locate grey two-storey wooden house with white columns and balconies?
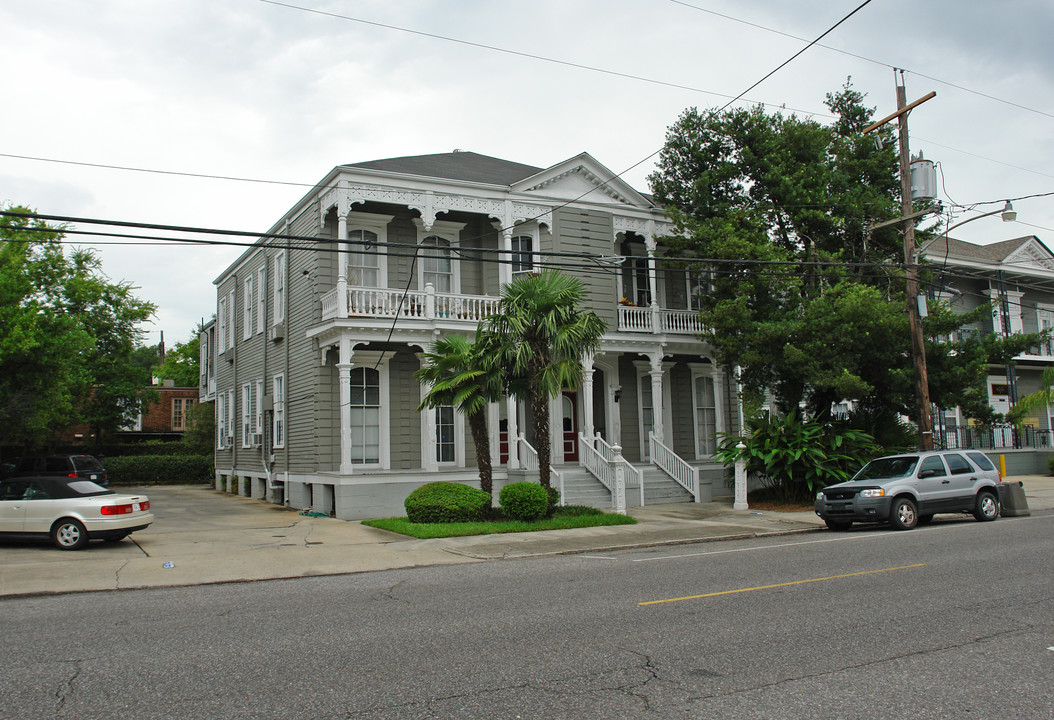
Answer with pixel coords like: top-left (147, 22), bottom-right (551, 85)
top-left (205, 152), bottom-right (740, 519)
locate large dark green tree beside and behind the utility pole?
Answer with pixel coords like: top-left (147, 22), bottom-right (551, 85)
top-left (648, 82), bottom-right (1036, 425)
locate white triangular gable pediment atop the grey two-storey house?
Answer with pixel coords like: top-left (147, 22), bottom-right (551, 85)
top-left (512, 153), bottom-right (651, 208)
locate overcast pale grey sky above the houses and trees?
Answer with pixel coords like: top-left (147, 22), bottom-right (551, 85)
top-left (0, 0), bottom-right (1054, 347)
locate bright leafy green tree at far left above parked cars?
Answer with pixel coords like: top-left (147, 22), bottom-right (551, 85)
top-left (0, 207), bottom-right (154, 447)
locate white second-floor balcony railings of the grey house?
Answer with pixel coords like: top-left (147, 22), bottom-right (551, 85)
top-left (321, 285), bottom-right (703, 335)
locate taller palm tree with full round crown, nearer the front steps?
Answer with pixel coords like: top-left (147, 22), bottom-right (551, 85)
top-left (487, 270), bottom-right (605, 488)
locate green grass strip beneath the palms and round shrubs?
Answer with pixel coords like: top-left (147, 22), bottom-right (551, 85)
top-left (363, 505), bottom-right (637, 540)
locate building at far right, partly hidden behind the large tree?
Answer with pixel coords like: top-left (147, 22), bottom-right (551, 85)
top-left (921, 235), bottom-right (1054, 448)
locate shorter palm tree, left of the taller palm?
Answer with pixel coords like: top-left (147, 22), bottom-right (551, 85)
top-left (414, 335), bottom-right (502, 495)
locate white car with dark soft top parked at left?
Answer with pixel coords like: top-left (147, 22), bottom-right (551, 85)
top-left (0, 478), bottom-right (154, 550)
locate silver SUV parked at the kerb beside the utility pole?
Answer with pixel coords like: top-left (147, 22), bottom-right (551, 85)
top-left (815, 450), bottom-right (1003, 530)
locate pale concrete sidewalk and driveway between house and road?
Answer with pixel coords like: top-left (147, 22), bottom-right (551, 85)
top-left (0, 475), bottom-right (1054, 597)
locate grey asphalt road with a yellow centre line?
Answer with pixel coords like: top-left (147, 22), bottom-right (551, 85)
top-left (0, 511), bottom-right (1054, 720)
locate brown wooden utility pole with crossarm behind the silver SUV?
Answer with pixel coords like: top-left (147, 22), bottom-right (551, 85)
top-left (863, 71), bottom-right (937, 450)
